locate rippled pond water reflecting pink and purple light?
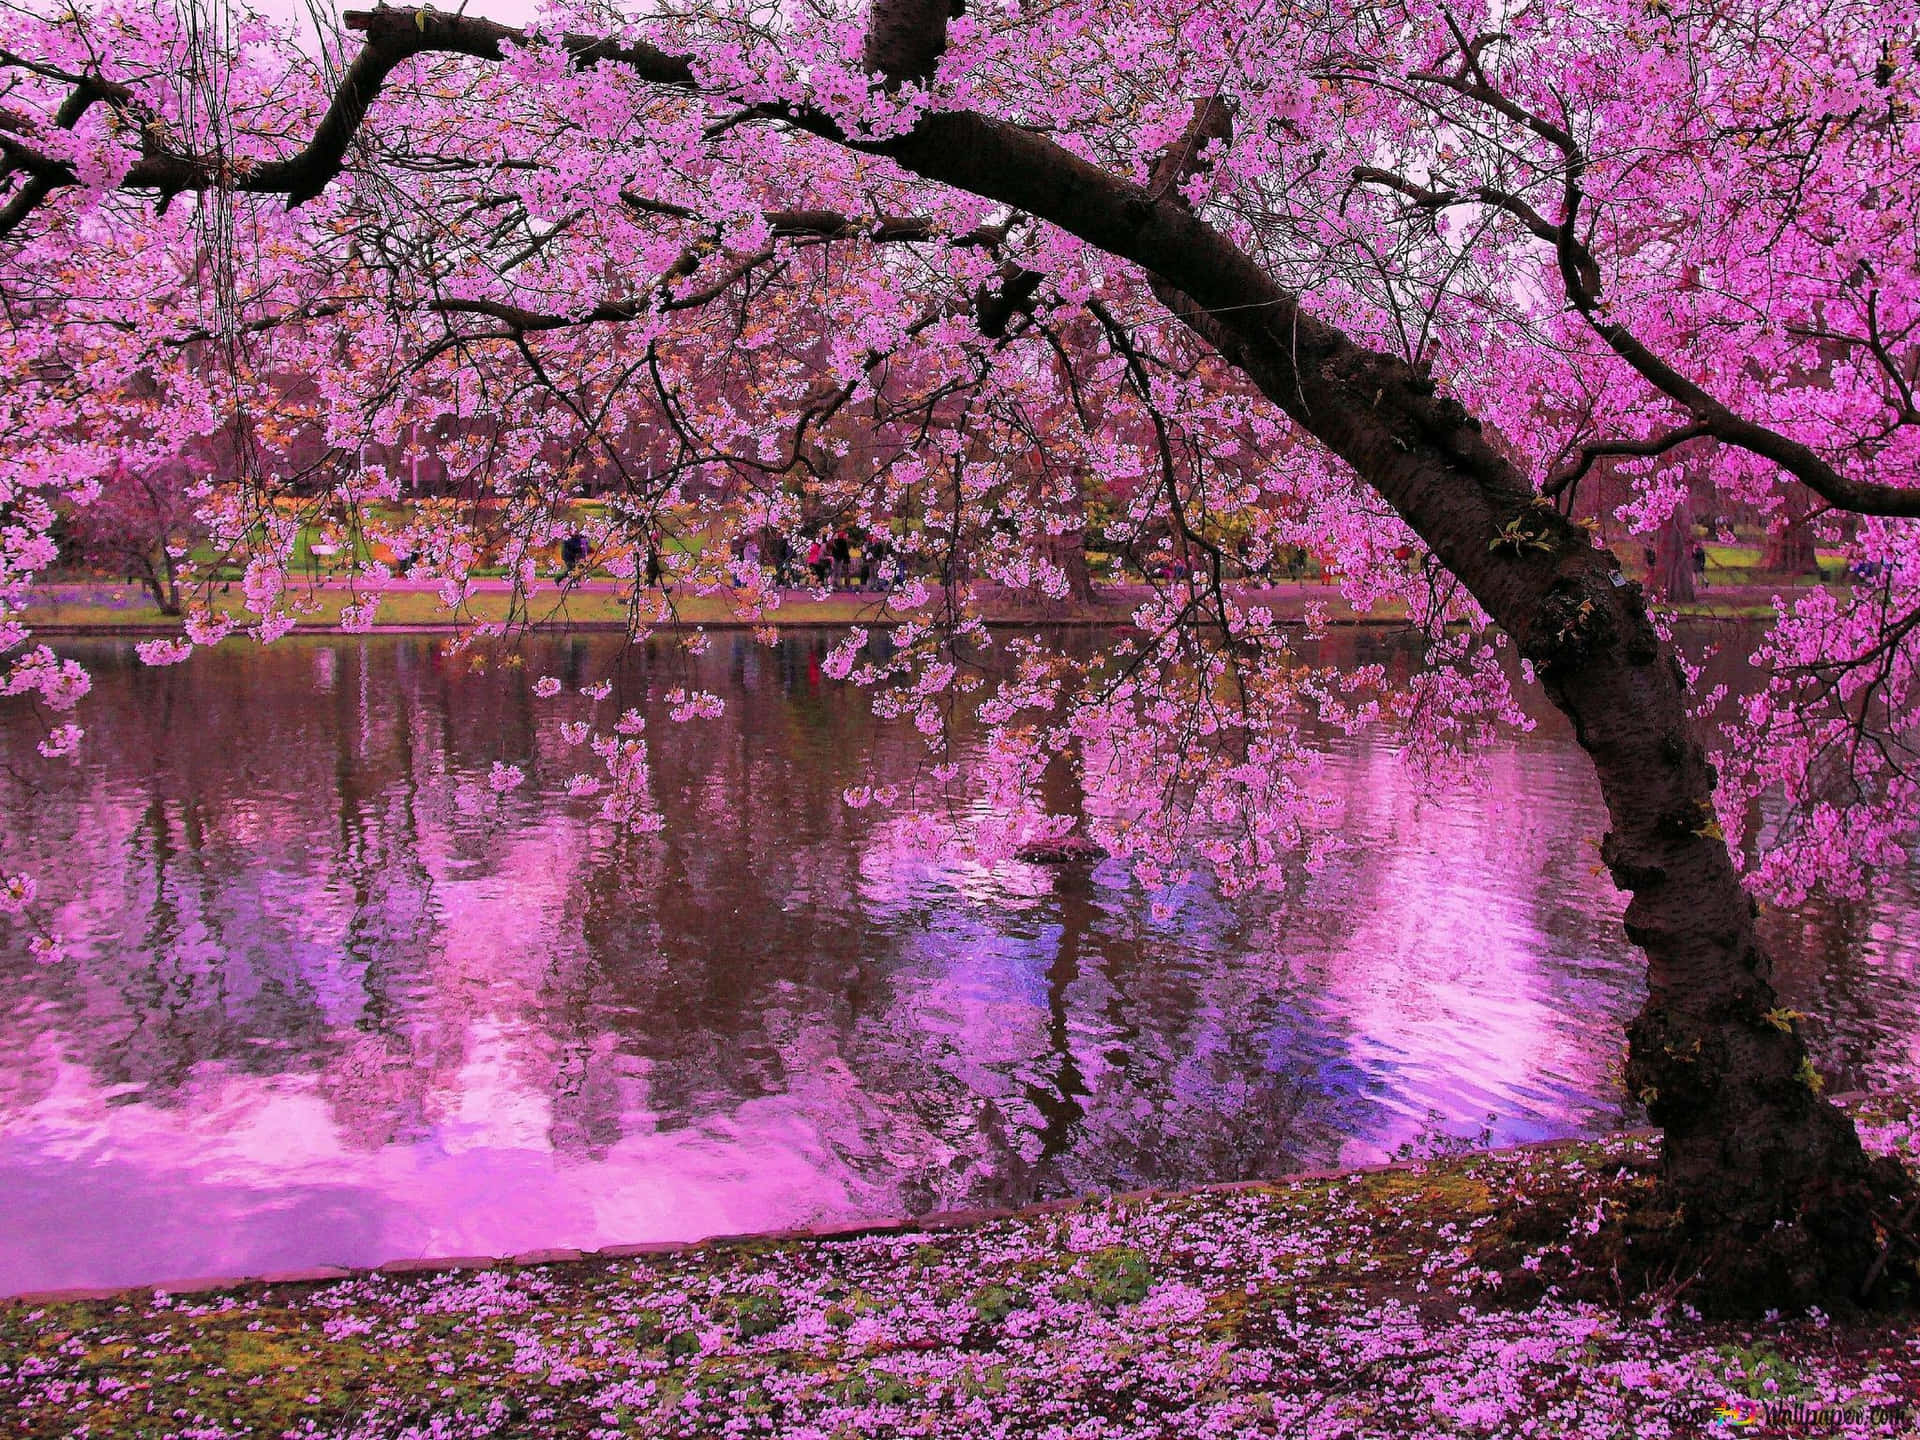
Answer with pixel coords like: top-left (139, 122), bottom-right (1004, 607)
top-left (0, 632), bottom-right (1920, 1294)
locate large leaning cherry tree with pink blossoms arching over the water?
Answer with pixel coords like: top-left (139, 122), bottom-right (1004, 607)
top-left (0, 0), bottom-right (1920, 1304)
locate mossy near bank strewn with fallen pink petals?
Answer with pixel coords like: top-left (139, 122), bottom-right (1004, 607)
top-left (0, 1096), bottom-right (1920, 1440)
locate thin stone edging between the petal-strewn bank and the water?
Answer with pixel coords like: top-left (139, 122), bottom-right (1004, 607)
top-left (0, 1128), bottom-right (1681, 1308)
